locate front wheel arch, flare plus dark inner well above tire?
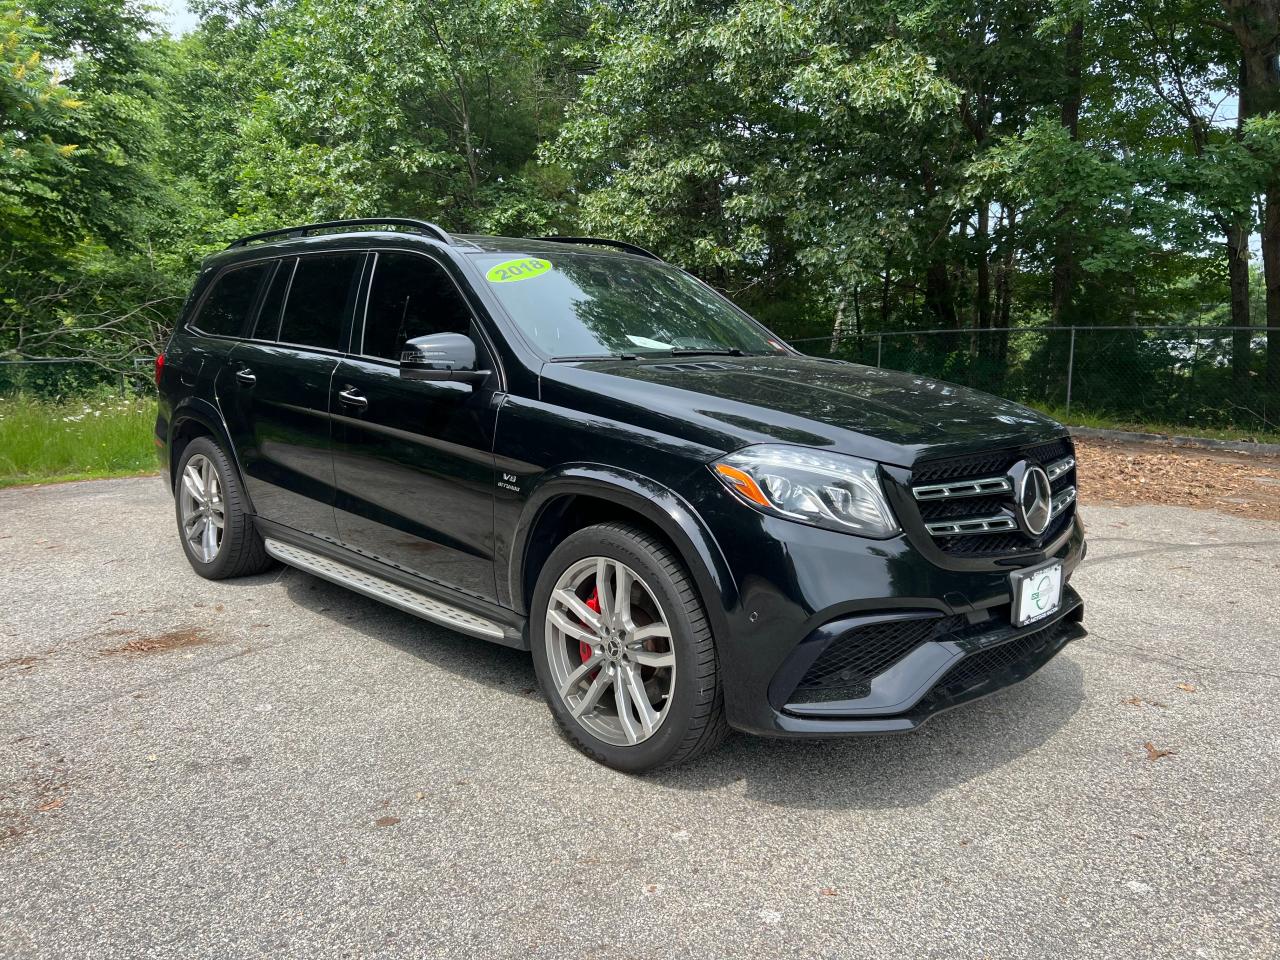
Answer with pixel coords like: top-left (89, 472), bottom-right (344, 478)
top-left (508, 465), bottom-right (737, 635)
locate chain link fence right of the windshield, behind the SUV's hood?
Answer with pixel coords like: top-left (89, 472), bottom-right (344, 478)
top-left (791, 326), bottom-right (1280, 435)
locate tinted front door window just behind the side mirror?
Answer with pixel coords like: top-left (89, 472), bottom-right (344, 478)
top-left (360, 253), bottom-right (471, 360)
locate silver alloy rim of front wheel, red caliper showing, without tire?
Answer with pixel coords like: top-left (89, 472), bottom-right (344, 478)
top-left (545, 557), bottom-right (676, 746)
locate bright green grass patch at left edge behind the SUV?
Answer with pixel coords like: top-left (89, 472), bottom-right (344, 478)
top-left (0, 396), bottom-right (157, 486)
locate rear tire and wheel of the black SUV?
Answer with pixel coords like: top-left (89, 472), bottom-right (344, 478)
top-left (173, 436), bottom-right (273, 580)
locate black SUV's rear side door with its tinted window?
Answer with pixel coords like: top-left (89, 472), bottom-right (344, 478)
top-left (220, 252), bottom-right (366, 540)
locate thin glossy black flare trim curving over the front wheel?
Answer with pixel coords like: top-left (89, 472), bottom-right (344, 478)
top-left (508, 463), bottom-right (737, 636)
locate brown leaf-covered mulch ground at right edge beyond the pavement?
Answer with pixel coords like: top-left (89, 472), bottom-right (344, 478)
top-left (1075, 440), bottom-right (1280, 521)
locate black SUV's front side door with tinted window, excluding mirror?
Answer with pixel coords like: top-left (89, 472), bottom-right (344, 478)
top-left (329, 251), bottom-right (497, 600)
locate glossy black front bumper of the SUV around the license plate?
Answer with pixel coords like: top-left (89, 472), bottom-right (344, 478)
top-left (703, 471), bottom-right (1085, 737)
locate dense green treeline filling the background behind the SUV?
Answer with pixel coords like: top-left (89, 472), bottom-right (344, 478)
top-left (0, 0), bottom-right (1280, 430)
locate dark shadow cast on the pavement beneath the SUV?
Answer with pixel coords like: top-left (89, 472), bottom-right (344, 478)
top-left (264, 570), bottom-right (1088, 809)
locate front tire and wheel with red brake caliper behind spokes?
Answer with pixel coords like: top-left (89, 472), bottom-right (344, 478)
top-left (529, 524), bottom-right (728, 773)
